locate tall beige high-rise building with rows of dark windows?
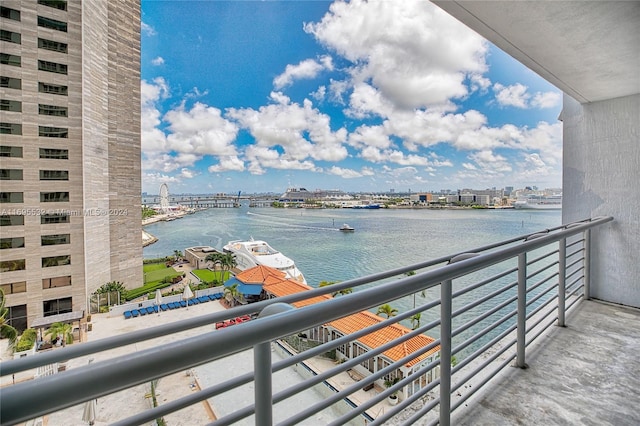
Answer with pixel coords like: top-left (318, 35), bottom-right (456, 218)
top-left (0, 0), bottom-right (142, 329)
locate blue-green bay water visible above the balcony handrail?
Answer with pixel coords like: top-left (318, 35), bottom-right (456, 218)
top-left (144, 205), bottom-right (562, 287)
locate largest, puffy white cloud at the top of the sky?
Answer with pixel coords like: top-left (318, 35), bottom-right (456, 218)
top-left (304, 0), bottom-right (487, 109)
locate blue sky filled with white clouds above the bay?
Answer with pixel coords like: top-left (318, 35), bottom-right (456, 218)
top-left (141, 0), bottom-right (562, 194)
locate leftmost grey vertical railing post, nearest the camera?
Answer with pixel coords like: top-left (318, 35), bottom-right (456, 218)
top-left (253, 342), bottom-right (273, 426)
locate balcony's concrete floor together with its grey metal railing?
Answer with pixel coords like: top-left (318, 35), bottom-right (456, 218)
top-left (0, 217), bottom-right (640, 425)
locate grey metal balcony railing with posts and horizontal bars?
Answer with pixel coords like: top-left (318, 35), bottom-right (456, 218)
top-left (0, 217), bottom-right (613, 425)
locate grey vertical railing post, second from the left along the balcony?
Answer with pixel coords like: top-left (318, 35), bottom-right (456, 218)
top-left (440, 280), bottom-right (453, 426)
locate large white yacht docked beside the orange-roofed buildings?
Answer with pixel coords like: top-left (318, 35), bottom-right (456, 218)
top-left (222, 238), bottom-right (307, 284)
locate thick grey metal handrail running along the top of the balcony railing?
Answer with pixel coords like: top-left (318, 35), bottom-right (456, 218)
top-left (0, 217), bottom-right (613, 424)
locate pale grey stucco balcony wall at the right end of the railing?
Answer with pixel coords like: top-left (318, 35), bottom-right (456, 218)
top-left (561, 95), bottom-right (640, 307)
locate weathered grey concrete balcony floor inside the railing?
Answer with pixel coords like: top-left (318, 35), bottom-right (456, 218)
top-left (451, 300), bottom-right (640, 426)
